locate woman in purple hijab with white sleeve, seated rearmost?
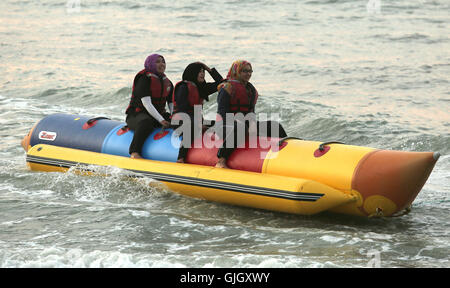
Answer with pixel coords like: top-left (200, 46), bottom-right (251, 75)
top-left (125, 54), bottom-right (173, 158)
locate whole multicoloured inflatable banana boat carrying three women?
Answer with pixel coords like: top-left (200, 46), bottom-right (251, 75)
top-left (22, 114), bottom-right (440, 217)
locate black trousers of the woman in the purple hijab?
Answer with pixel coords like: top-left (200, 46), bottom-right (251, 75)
top-left (126, 112), bottom-right (170, 155)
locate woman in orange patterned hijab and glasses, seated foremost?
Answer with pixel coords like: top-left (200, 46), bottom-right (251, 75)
top-left (216, 60), bottom-right (287, 168)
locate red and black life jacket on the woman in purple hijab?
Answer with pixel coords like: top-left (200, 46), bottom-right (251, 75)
top-left (125, 69), bottom-right (172, 114)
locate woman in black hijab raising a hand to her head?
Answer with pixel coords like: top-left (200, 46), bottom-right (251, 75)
top-left (172, 62), bottom-right (227, 163)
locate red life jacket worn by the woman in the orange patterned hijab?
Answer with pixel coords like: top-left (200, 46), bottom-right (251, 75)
top-left (228, 80), bottom-right (258, 115)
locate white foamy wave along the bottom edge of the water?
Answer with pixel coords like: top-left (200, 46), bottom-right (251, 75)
top-left (0, 242), bottom-right (326, 268)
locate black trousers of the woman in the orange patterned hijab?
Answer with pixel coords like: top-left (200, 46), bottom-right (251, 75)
top-left (217, 121), bottom-right (287, 159)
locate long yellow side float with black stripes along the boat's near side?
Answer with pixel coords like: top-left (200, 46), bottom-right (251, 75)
top-left (27, 144), bottom-right (357, 215)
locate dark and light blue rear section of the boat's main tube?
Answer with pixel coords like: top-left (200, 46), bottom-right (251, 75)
top-left (30, 114), bottom-right (181, 162)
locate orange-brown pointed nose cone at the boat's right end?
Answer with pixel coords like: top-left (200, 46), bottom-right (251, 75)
top-left (352, 150), bottom-right (440, 216)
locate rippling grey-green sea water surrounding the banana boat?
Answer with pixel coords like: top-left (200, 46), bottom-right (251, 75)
top-left (0, 0), bottom-right (450, 268)
